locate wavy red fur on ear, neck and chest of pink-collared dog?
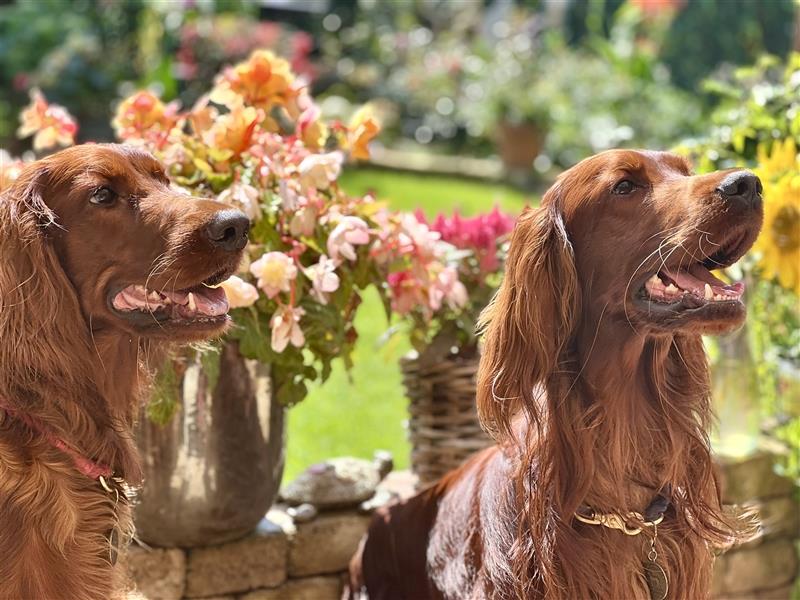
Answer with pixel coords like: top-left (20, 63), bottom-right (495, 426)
top-left (0, 161), bottom-right (140, 600)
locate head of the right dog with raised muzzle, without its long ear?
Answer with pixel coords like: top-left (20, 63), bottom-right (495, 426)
top-left (544, 150), bottom-right (763, 334)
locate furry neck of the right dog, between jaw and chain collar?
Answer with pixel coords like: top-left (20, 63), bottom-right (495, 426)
top-left (573, 320), bottom-right (711, 511)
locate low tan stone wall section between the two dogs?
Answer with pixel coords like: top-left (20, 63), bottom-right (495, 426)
top-left (127, 508), bottom-right (369, 600)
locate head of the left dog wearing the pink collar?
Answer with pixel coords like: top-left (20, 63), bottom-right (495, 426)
top-left (0, 144), bottom-right (249, 341)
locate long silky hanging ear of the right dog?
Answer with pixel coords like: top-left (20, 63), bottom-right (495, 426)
top-left (477, 183), bottom-right (579, 440)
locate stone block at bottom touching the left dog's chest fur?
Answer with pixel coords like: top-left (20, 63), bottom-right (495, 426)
top-left (123, 546), bottom-right (186, 600)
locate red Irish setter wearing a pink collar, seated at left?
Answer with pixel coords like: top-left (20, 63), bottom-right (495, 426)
top-left (0, 145), bottom-right (249, 600)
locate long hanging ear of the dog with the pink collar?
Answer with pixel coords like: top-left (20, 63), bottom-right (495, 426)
top-left (0, 163), bottom-right (85, 394)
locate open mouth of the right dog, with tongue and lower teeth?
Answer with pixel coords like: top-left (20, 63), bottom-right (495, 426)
top-left (639, 233), bottom-right (751, 308)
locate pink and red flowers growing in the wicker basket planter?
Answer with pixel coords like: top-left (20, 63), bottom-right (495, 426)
top-left (388, 207), bottom-right (514, 353)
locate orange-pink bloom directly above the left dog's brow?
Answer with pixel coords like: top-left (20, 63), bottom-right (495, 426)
top-left (111, 90), bottom-right (179, 140)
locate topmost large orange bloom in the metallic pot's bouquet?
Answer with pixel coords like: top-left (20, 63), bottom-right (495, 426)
top-left (211, 50), bottom-right (297, 111)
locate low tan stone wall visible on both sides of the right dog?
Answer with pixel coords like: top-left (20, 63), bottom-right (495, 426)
top-left (127, 454), bottom-right (800, 600)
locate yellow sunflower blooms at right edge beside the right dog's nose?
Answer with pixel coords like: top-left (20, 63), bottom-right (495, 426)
top-left (753, 139), bottom-right (800, 295)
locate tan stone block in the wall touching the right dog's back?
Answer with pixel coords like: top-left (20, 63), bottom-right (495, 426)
top-left (289, 512), bottom-right (370, 577)
